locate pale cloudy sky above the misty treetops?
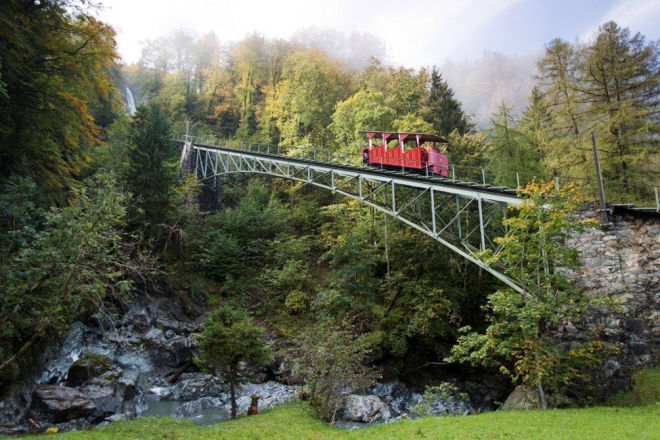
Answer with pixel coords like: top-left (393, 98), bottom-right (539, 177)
top-left (98, 0), bottom-right (660, 67)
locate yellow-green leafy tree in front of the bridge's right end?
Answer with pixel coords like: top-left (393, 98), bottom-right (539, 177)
top-left (448, 182), bottom-right (609, 406)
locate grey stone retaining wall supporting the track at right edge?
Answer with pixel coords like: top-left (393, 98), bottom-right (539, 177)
top-left (568, 213), bottom-right (660, 377)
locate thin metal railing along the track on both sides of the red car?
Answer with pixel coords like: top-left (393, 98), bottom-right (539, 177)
top-left (174, 135), bottom-right (660, 212)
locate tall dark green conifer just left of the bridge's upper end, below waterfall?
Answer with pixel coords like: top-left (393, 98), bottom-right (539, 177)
top-left (123, 105), bottom-right (176, 227)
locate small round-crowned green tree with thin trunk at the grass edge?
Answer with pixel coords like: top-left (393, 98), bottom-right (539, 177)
top-left (197, 306), bottom-right (272, 419)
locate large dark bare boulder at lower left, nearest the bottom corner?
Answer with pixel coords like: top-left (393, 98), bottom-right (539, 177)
top-left (31, 385), bottom-right (96, 423)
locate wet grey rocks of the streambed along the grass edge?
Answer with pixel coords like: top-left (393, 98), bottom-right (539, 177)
top-left (0, 294), bottom-right (501, 433)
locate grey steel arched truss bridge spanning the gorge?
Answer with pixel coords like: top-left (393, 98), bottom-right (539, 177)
top-left (174, 138), bottom-right (523, 292)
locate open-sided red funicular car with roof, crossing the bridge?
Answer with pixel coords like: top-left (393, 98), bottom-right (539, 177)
top-left (362, 131), bottom-right (449, 177)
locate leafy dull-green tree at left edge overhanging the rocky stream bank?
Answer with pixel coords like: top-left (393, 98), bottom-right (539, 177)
top-left (0, 174), bottom-right (154, 388)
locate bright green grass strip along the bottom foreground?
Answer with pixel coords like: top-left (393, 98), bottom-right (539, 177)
top-left (10, 368), bottom-right (660, 440)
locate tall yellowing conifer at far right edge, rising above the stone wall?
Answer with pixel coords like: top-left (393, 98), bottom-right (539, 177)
top-left (580, 22), bottom-right (660, 182)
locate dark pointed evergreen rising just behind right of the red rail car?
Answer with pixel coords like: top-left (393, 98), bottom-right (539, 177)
top-left (423, 67), bottom-right (473, 136)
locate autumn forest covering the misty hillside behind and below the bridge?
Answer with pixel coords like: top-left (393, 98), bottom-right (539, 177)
top-left (0, 0), bottom-right (660, 434)
